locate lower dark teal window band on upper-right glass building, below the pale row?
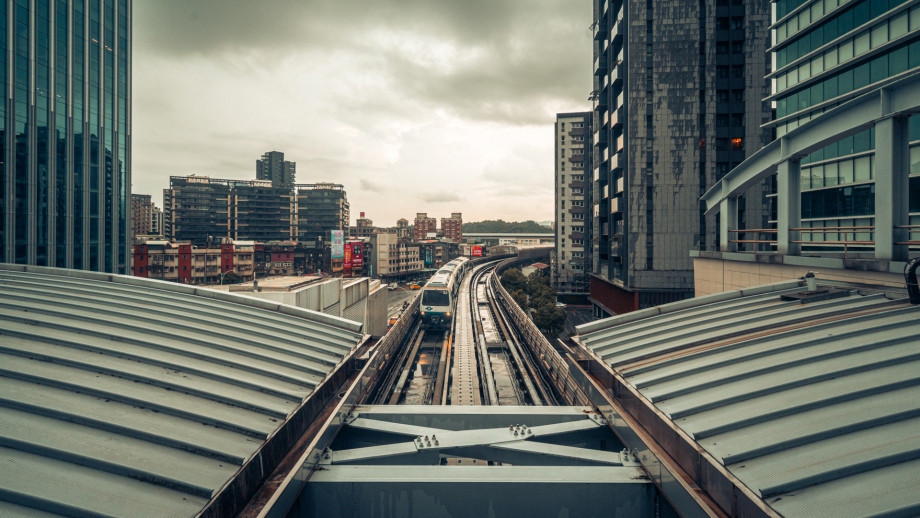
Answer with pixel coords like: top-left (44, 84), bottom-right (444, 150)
top-left (776, 40), bottom-right (920, 118)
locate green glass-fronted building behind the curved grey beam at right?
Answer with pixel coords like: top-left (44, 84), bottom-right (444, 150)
top-left (766, 0), bottom-right (920, 245)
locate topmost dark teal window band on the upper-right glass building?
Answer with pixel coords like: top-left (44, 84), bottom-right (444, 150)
top-left (776, 0), bottom-right (907, 68)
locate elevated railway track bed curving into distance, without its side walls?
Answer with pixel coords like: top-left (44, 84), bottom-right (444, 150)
top-left (371, 261), bottom-right (558, 406)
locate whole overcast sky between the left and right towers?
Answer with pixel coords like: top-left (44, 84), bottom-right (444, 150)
top-left (132, 0), bottom-right (592, 226)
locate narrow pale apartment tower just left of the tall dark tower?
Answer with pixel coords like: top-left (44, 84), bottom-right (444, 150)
top-left (551, 112), bottom-right (594, 295)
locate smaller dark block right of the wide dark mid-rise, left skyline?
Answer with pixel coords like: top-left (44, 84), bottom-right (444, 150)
top-left (294, 183), bottom-right (351, 249)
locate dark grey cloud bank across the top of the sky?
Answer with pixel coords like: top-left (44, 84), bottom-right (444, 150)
top-left (135, 0), bottom-right (591, 124)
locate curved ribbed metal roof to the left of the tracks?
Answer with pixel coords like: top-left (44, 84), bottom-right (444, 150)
top-left (0, 265), bottom-right (365, 517)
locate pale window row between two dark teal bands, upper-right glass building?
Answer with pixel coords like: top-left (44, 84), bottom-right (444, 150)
top-left (775, 6), bottom-right (920, 93)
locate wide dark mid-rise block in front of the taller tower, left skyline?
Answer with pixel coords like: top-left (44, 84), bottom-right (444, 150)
top-left (163, 176), bottom-right (293, 246)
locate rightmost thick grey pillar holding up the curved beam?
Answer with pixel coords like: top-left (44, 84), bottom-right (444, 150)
top-left (875, 117), bottom-right (910, 261)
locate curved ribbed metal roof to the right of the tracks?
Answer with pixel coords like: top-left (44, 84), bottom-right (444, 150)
top-left (578, 283), bottom-right (920, 517)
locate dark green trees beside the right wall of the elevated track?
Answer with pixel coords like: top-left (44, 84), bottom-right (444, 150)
top-left (501, 268), bottom-right (565, 336)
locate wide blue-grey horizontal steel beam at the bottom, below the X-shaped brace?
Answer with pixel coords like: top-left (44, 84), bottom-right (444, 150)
top-left (299, 466), bottom-right (656, 518)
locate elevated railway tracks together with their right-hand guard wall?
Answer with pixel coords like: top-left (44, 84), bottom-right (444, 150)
top-left (366, 260), bottom-right (585, 412)
